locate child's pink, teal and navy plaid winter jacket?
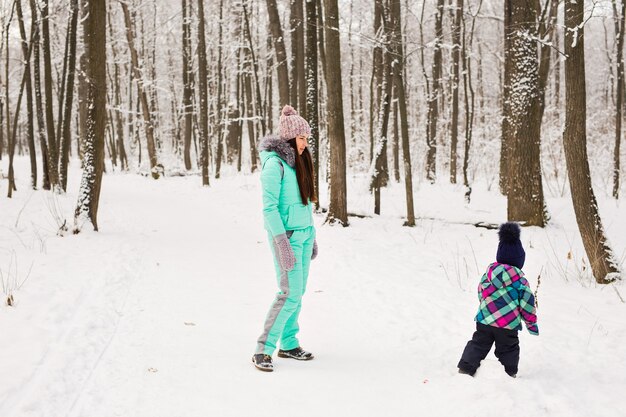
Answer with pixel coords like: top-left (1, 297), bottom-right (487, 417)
top-left (476, 262), bottom-right (539, 335)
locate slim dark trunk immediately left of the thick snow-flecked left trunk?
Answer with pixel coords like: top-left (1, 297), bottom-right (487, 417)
top-left (59, 0), bottom-right (78, 191)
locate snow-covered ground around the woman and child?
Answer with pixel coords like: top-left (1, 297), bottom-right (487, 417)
top-left (0, 159), bottom-right (626, 417)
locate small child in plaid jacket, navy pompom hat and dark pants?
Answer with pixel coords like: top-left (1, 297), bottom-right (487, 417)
top-left (458, 222), bottom-right (539, 378)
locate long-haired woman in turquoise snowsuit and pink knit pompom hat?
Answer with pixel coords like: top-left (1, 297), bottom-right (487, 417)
top-left (252, 106), bottom-right (317, 372)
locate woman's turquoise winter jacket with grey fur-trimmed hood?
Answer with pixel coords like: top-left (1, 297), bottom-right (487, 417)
top-left (259, 135), bottom-right (313, 237)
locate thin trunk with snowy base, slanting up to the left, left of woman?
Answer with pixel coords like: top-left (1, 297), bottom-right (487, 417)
top-left (120, 2), bottom-right (162, 179)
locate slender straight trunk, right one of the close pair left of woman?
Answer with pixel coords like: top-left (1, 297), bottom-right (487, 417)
top-left (198, 0), bottom-right (209, 186)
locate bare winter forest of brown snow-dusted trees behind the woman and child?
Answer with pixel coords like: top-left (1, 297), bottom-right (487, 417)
top-left (0, 0), bottom-right (626, 283)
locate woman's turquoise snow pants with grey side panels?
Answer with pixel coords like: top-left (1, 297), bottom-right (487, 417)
top-left (256, 226), bottom-right (315, 355)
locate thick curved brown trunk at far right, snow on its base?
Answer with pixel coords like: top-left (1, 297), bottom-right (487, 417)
top-left (563, 0), bottom-right (619, 284)
